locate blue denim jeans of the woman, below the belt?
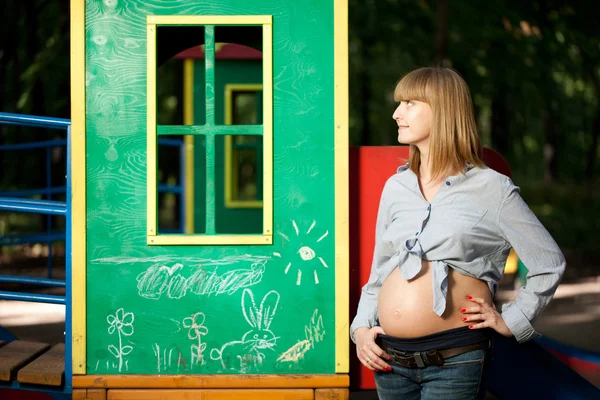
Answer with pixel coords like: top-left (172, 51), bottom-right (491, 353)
top-left (375, 349), bottom-right (491, 400)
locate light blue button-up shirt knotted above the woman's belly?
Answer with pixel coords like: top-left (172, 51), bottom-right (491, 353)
top-left (350, 165), bottom-right (565, 342)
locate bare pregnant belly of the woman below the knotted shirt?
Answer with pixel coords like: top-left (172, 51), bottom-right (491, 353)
top-left (378, 260), bottom-right (491, 338)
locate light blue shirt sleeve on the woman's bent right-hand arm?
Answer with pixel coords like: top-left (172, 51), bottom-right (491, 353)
top-left (498, 179), bottom-right (566, 343)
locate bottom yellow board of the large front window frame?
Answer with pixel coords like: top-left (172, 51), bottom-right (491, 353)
top-left (148, 234), bottom-right (273, 246)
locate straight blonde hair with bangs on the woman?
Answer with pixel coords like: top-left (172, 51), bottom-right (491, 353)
top-left (394, 67), bottom-right (484, 179)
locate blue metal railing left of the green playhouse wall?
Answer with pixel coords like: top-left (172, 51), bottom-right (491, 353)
top-left (0, 113), bottom-right (73, 393)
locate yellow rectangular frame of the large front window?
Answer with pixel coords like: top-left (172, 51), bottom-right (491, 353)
top-left (146, 15), bottom-right (273, 245)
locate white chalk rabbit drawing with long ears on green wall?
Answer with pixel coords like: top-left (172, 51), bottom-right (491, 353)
top-left (210, 289), bottom-right (279, 373)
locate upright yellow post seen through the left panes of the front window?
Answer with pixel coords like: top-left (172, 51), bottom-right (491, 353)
top-left (182, 58), bottom-right (196, 234)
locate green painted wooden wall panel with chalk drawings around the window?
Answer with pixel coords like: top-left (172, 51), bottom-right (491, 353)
top-left (85, 0), bottom-right (336, 374)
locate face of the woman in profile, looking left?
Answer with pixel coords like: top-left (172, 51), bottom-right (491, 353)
top-left (392, 100), bottom-right (431, 146)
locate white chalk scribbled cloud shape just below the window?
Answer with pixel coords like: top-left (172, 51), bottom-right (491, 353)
top-left (137, 259), bottom-right (266, 300)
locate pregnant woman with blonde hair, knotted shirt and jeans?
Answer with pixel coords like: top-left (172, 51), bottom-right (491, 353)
top-left (351, 68), bottom-right (565, 400)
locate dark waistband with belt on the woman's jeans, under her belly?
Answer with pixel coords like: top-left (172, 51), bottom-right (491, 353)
top-left (376, 326), bottom-right (493, 351)
